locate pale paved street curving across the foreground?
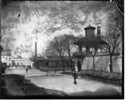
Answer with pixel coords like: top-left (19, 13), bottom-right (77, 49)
top-left (6, 67), bottom-right (121, 95)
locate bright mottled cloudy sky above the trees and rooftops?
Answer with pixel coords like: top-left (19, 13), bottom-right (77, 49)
top-left (1, 1), bottom-right (119, 58)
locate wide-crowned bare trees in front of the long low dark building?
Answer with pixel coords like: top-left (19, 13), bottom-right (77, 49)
top-left (47, 34), bottom-right (78, 72)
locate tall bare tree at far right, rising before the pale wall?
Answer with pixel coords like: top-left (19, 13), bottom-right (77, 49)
top-left (104, 25), bottom-right (122, 72)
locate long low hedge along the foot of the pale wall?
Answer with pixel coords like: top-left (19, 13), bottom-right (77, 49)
top-left (80, 70), bottom-right (122, 85)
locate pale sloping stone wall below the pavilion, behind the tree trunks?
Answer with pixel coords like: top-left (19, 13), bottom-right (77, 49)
top-left (82, 56), bottom-right (122, 73)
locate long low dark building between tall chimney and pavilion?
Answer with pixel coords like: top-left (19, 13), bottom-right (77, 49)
top-left (32, 56), bottom-right (71, 70)
